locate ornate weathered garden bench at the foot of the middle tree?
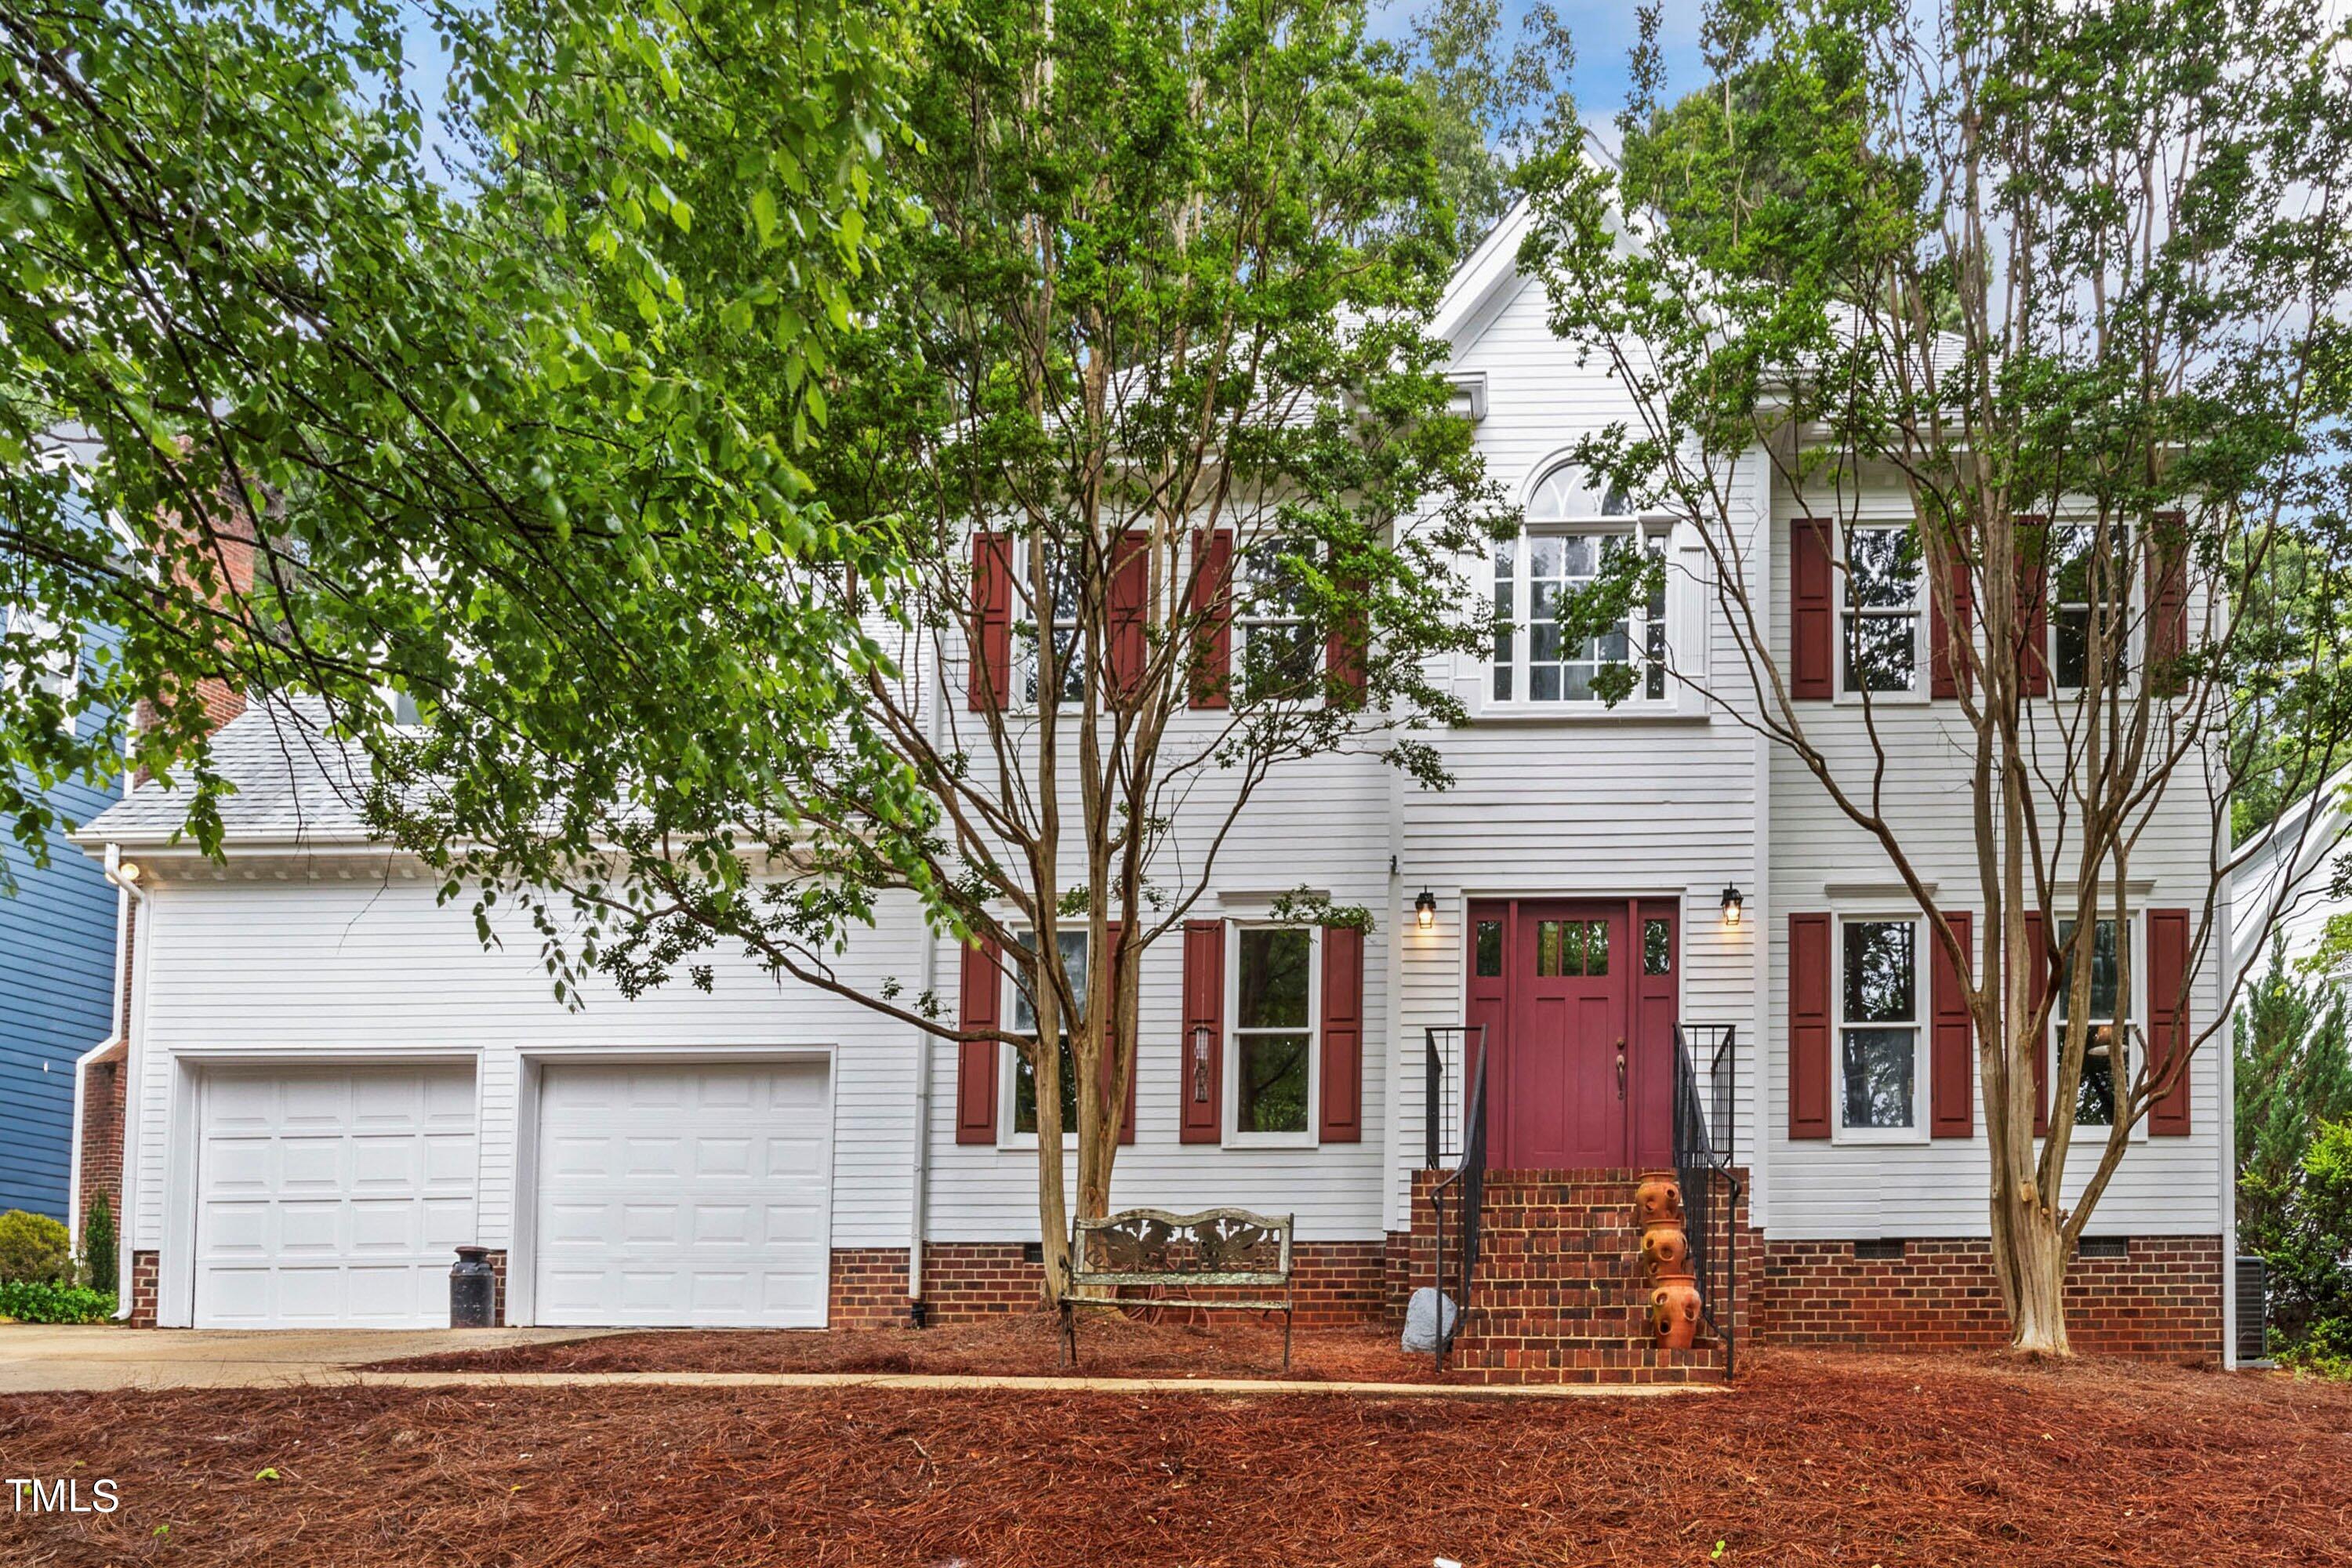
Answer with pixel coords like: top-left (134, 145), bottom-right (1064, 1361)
top-left (1061, 1208), bottom-right (1294, 1373)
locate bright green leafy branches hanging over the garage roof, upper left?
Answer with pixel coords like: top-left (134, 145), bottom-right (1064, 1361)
top-left (0, 0), bottom-right (906, 855)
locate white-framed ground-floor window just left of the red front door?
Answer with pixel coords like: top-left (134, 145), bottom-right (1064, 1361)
top-left (1225, 924), bottom-right (1322, 1145)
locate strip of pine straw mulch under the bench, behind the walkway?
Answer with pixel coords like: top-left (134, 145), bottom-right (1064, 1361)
top-left (369, 1307), bottom-right (1437, 1382)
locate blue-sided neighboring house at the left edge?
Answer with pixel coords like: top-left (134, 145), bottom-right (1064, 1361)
top-left (0, 612), bottom-right (122, 1225)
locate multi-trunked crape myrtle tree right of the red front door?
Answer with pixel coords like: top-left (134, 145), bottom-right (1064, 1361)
top-left (1522, 0), bottom-right (2352, 1354)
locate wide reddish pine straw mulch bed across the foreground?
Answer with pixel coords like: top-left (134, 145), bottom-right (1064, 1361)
top-left (0, 1352), bottom-right (2352, 1568)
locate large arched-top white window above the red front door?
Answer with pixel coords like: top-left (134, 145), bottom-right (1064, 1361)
top-left (1486, 468), bottom-right (1668, 710)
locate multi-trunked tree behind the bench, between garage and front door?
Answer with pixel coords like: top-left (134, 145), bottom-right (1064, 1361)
top-left (360, 0), bottom-right (1503, 1290)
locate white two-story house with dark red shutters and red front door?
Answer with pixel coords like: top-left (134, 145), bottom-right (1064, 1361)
top-left (82, 205), bottom-right (2232, 1359)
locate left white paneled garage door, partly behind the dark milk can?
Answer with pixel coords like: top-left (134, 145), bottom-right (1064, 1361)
top-left (195, 1065), bottom-right (475, 1328)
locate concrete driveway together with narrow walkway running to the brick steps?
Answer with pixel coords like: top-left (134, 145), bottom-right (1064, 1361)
top-left (0, 1323), bottom-right (1719, 1399)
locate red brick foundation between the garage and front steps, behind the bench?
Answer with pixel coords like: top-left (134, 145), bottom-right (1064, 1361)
top-left (830, 1241), bottom-right (1390, 1328)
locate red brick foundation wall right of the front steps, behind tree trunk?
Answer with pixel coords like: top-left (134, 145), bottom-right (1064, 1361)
top-left (1740, 1236), bottom-right (2223, 1361)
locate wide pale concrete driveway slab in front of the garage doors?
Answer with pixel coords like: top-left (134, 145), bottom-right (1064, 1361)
top-left (0, 1323), bottom-right (609, 1394)
